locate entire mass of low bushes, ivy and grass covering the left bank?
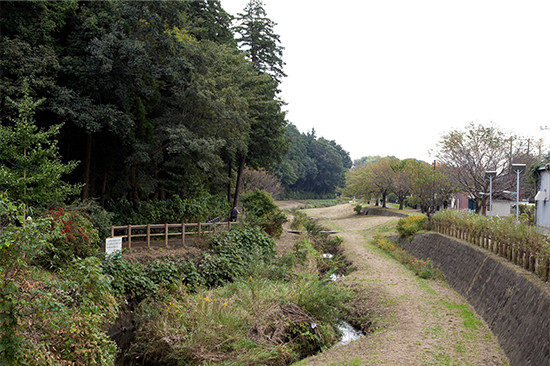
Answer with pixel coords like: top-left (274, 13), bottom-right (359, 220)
top-left (0, 190), bottom-right (358, 365)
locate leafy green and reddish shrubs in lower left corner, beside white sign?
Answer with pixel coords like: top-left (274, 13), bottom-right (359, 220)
top-left (0, 196), bottom-right (117, 365)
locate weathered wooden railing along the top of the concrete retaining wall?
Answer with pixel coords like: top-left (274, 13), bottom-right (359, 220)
top-left (432, 222), bottom-right (550, 282)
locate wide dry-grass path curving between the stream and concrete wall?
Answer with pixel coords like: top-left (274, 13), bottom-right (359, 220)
top-left (298, 204), bottom-right (508, 366)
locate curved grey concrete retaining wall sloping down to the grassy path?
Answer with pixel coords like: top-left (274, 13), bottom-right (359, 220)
top-left (401, 233), bottom-right (550, 366)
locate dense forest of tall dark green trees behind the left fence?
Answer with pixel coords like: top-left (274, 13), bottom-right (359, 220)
top-left (0, 0), bottom-right (351, 219)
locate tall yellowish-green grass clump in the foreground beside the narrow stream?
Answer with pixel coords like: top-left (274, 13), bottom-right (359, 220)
top-left (132, 264), bottom-right (350, 365)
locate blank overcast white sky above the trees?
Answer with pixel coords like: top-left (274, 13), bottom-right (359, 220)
top-left (221, 0), bottom-right (550, 161)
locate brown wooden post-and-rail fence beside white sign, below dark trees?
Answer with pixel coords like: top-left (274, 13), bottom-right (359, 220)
top-left (111, 222), bottom-right (235, 249)
